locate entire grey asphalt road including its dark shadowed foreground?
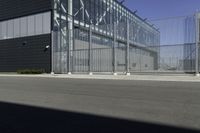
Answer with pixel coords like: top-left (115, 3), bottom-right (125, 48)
top-left (0, 77), bottom-right (200, 133)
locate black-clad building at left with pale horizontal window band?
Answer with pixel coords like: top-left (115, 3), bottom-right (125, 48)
top-left (0, 0), bottom-right (52, 72)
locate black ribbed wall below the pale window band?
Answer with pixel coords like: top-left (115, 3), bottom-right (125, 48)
top-left (0, 34), bottom-right (51, 72)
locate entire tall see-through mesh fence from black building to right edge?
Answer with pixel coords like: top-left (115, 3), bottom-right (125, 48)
top-left (52, 0), bottom-right (200, 73)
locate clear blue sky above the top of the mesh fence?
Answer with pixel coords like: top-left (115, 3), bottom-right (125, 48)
top-left (124, 0), bottom-right (200, 19)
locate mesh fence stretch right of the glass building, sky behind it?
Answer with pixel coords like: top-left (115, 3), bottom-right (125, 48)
top-left (151, 13), bottom-right (199, 73)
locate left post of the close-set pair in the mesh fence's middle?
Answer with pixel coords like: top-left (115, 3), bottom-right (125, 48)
top-left (113, 22), bottom-right (117, 75)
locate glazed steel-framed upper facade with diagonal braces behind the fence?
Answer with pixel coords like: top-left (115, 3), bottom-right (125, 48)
top-left (52, 0), bottom-right (160, 74)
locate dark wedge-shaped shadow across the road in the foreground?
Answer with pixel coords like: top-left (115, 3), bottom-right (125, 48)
top-left (0, 102), bottom-right (199, 133)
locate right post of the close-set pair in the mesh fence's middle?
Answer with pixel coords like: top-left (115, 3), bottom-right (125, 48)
top-left (126, 19), bottom-right (131, 76)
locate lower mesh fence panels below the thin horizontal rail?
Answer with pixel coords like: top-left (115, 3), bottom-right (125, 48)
top-left (57, 44), bottom-right (196, 73)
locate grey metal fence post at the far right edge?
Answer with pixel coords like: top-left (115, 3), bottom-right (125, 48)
top-left (195, 12), bottom-right (200, 76)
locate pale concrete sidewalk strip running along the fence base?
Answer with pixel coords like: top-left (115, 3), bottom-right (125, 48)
top-left (0, 73), bottom-right (200, 82)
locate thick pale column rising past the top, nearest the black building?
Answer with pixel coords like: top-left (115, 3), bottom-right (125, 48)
top-left (67, 0), bottom-right (73, 75)
